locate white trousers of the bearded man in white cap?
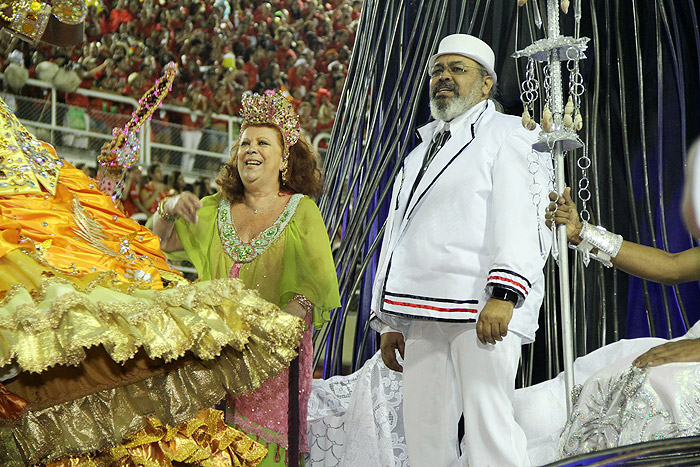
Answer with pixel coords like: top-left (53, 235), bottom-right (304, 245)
top-left (403, 322), bottom-right (530, 467)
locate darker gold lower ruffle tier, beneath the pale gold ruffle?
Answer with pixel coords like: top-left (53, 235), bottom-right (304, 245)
top-left (0, 316), bottom-right (294, 466)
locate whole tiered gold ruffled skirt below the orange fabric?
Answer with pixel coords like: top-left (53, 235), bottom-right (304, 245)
top-left (0, 250), bottom-right (303, 466)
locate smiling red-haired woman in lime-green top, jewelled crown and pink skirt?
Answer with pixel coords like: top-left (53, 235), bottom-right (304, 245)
top-left (152, 91), bottom-right (340, 465)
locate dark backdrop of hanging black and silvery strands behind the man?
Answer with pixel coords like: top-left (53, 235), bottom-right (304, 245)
top-left (316, 0), bottom-right (700, 385)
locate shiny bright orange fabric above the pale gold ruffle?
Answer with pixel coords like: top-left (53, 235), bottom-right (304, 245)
top-left (0, 145), bottom-right (172, 288)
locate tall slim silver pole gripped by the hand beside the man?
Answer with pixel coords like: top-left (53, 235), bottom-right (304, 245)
top-left (547, 0), bottom-right (574, 413)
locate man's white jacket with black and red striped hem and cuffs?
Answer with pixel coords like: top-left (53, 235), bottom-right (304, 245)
top-left (370, 101), bottom-right (552, 342)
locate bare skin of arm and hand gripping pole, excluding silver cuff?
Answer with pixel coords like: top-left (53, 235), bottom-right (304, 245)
top-left (547, 187), bottom-right (700, 285)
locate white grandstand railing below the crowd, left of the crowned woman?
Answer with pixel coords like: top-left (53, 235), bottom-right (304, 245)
top-left (0, 73), bottom-right (240, 178)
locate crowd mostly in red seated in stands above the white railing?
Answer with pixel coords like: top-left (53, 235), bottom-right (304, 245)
top-left (0, 0), bottom-right (362, 142)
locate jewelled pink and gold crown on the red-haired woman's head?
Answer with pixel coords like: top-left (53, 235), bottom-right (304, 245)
top-left (241, 89), bottom-right (301, 148)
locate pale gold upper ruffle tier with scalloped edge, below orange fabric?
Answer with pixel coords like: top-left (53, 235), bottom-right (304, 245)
top-left (0, 250), bottom-right (302, 372)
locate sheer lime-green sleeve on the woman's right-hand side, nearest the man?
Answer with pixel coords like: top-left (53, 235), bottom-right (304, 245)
top-left (280, 197), bottom-right (340, 329)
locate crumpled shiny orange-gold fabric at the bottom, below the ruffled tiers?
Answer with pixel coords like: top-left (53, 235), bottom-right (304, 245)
top-left (47, 409), bottom-right (267, 467)
